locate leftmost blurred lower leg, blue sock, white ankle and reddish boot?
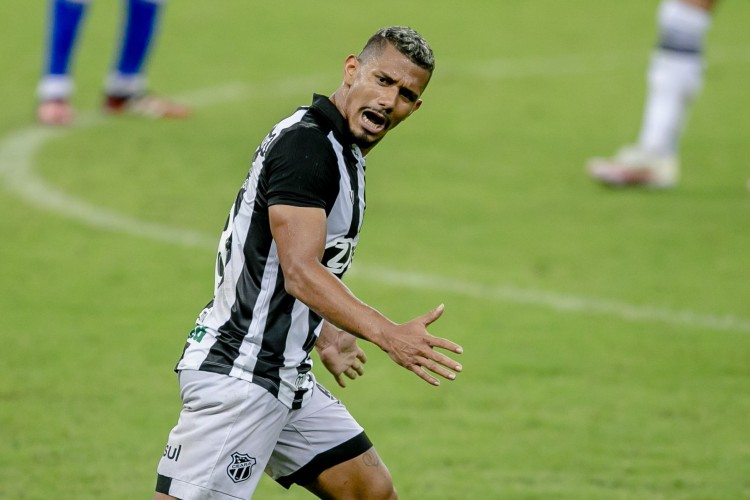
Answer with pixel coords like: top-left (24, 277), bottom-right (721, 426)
top-left (37, 0), bottom-right (89, 125)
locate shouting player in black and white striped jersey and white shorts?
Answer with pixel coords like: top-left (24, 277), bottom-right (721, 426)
top-left (154, 27), bottom-right (462, 500)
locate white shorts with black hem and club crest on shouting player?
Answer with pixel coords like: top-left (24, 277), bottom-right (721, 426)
top-left (156, 370), bottom-right (372, 500)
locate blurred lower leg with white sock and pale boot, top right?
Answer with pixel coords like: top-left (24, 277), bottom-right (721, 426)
top-left (587, 0), bottom-right (718, 188)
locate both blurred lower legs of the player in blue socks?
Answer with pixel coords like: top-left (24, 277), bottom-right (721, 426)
top-left (37, 0), bottom-right (190, 125)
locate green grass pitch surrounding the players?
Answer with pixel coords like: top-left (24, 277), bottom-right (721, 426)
top-left (0, 0), bottom-right (750, 500)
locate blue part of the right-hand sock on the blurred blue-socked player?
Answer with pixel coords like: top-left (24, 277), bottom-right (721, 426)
top-left (117, 0), bottom-right (160, 76)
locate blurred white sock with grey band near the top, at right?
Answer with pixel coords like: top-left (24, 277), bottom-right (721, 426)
top-left (638, 0), bottom-right (711, 155)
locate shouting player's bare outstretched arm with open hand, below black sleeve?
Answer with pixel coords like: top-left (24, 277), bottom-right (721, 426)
top-left (269, 205), bottom-right (463, 385)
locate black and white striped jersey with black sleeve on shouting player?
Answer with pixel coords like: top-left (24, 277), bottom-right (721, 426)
top-left (177, 95), bottom-right (365, 408)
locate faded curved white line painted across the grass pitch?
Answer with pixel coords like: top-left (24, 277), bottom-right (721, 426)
top-left (0, 68), bottom-right (750, 332)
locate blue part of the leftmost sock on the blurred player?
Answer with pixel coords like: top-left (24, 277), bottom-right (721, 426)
top-left (44, 0), bottom-right (87, 75)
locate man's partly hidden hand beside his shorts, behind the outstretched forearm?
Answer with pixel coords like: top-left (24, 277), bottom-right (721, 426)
top-left (315, 320), bottom-right (367, 387)
